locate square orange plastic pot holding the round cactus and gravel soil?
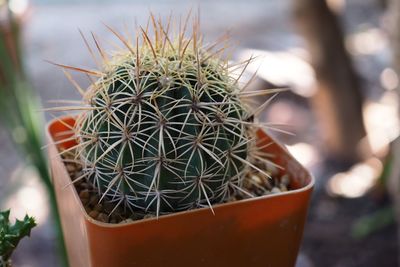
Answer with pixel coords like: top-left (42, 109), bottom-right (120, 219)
top-left (47, 117), bottom-right (314, 267)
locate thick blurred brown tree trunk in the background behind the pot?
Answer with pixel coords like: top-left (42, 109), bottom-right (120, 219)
top-left (293, 0), bottom-right (366, 163)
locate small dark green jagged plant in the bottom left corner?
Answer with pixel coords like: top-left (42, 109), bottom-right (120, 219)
top-left (0, 210), bottom-right (36, 267)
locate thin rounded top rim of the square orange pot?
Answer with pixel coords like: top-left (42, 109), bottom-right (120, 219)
top-left (46, 115), bottom-right (315, 228)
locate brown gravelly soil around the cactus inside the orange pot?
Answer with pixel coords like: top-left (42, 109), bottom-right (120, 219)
top-left (61, 147), bottom-right (291, 224)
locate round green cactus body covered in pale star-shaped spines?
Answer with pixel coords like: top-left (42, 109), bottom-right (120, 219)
top-left (75, 23), bottom-right (251, 218)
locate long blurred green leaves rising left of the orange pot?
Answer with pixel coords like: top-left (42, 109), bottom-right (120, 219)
top-left (0, 1), bottom-right (68, 266)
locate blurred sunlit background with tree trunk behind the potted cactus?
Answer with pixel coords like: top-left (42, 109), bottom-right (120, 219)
top-left (0, 0), bottom-right (400, 267)
